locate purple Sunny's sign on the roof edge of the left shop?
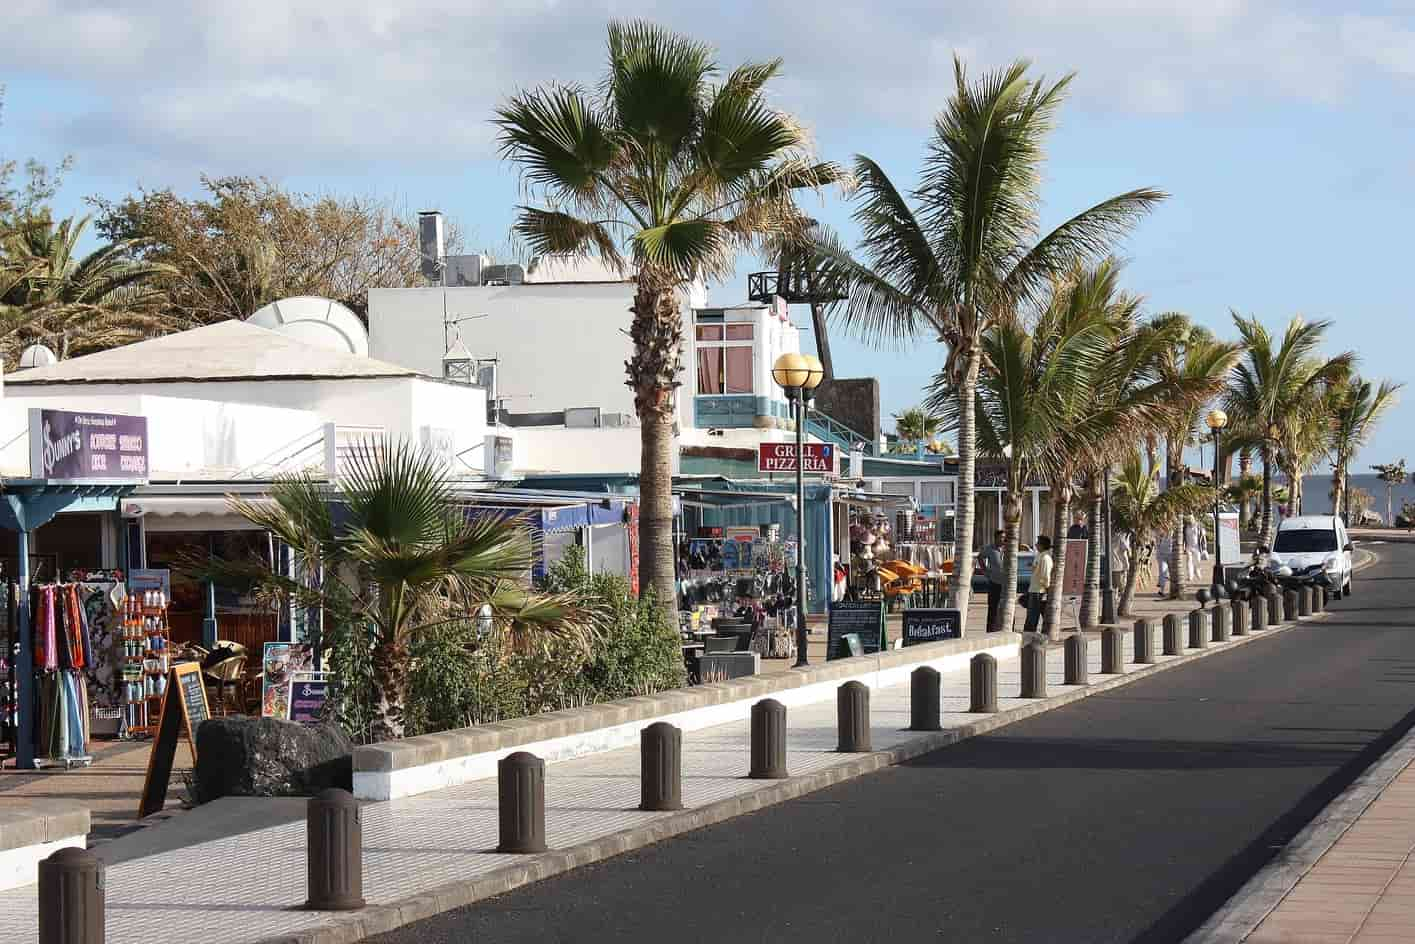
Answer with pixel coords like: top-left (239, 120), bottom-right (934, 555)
top-left (30, 409), bottom-right (147, 483)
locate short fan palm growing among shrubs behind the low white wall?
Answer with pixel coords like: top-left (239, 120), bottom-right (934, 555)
top-left (209, 439), bottom-right (596, 737)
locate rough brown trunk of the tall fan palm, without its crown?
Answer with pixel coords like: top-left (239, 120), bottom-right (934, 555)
top-left (627, 277), bottom-right (687, 620)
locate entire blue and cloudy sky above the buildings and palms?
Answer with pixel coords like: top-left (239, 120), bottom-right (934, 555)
top-left (8, 0), bottom-right (1415, 471)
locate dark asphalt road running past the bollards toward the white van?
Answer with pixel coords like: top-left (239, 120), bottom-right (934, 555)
top-left (374, 545), bottom-right (1415, 944)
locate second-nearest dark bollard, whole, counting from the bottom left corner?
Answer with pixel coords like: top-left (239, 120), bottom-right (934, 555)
top-left (304, 787), bottom-right (364, 911)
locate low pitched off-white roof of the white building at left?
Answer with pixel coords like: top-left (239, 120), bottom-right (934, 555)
top-left (4, 321), bottom-right (419, 385)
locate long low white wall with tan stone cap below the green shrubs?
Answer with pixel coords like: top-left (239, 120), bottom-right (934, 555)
top-left (354, 633), bottom-right (1019, 800)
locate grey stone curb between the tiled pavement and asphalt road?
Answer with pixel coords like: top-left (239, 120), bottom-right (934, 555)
top-left (256, 583), bottom-right (1375, 944)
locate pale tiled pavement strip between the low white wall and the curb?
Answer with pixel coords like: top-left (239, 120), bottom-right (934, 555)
top-left (0, 608), bottom-right (1290, 944)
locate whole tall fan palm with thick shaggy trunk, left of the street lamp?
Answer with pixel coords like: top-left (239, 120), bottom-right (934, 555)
top-left (497, 21), bottom-right (843, 617)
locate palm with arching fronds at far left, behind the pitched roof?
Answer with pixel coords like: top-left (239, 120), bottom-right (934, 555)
top-left (0, 214), bottom-right (171, 368)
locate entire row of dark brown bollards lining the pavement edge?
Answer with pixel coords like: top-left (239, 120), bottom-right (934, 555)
top-left (47, 587), bottom-right (1347, 944)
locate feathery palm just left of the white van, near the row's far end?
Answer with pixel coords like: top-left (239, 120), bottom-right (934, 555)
top-left (1224, 313), bottom-right (1354, 543)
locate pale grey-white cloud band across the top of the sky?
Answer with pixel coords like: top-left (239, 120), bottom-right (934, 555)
top-left (0, 0), bottom-right (1415, 174)
